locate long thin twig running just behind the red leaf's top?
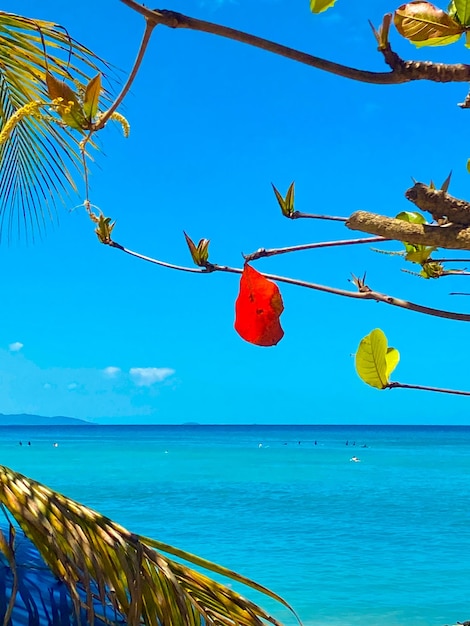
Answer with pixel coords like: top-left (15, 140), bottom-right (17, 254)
top-left (107, 241), bottom-right (470, 322)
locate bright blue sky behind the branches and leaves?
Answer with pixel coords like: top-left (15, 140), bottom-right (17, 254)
top-left (0, 0), bottom-right (470, 424)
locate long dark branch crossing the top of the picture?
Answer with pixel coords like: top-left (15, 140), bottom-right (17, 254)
top-left (121, 0), bottom-right (470, 85)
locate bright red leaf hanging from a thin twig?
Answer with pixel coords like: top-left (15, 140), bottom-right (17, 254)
top-left (235, 263), bottom-right (284, 346)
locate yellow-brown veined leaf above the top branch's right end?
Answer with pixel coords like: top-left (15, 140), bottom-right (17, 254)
top-left (393, 2), bottom-right (465, 46)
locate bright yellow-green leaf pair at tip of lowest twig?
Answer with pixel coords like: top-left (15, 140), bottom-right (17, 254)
top-left (355, 328), bottom-right (400, 389)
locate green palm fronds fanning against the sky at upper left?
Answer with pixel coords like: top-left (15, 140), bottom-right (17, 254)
top-left (0, 11), bottom-right (105, 239)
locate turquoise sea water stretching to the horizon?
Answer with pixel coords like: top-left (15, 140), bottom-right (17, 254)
top-left (0, 426), bottom-right (470, 626)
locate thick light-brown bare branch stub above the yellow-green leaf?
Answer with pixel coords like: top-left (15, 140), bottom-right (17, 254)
top-left (346, 211), bottom-right (470, 250)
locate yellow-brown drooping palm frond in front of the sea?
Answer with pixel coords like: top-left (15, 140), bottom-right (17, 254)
top-left (0, 466), bottom-right (300, 626)
